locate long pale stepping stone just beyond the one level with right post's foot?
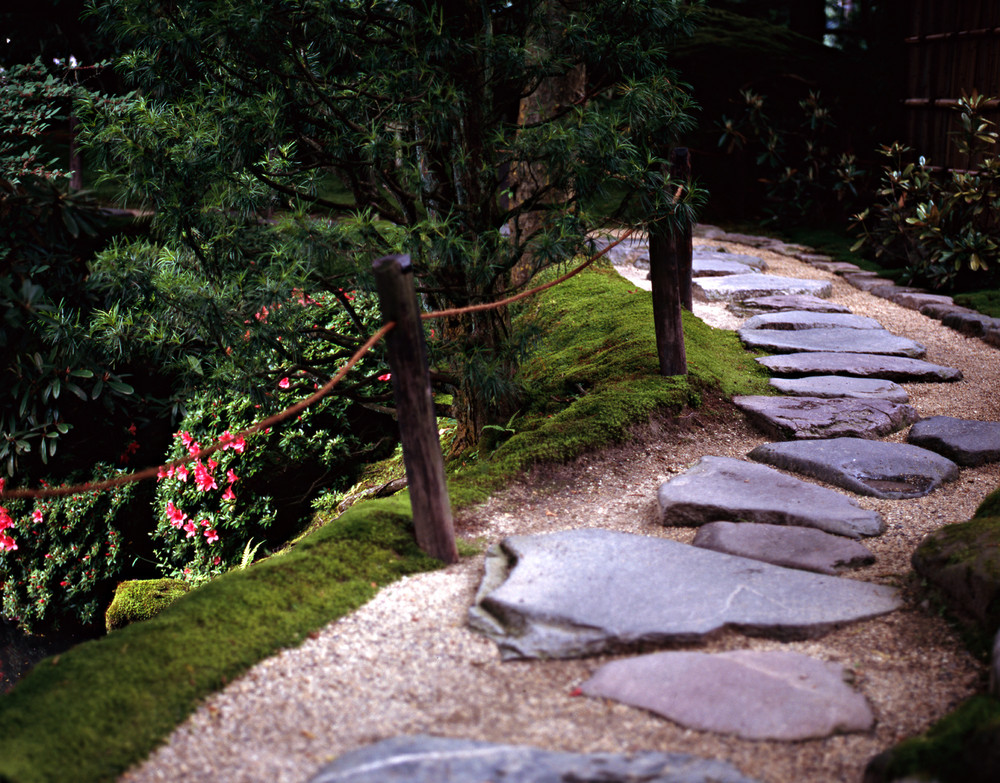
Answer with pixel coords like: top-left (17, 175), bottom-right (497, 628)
top-left (736, 326), bottom-right (927, 359)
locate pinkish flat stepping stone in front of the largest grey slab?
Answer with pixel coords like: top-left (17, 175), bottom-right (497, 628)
top-left (581, 650), bottom-right (875, 741)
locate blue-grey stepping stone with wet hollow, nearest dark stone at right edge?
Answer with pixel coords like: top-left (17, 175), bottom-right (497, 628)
top-left (748, 438), bottom-right (958, 500)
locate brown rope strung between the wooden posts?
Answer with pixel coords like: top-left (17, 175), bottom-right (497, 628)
top-left (0, 228), bottom-right (635, 499)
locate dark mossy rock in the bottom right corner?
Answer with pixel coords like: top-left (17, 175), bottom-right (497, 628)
top-left (864, 696), bottom-right (1000, 783)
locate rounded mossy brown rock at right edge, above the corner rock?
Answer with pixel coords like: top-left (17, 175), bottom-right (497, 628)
top-left (912, 516), bottom-right (1000, 635)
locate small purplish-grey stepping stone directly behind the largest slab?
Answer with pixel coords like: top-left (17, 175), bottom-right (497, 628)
top-left (691, 522), bottom-right (875, 575)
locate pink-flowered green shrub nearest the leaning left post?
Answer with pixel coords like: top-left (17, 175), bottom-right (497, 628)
top-left (153, 378), bottom-right (374, 583)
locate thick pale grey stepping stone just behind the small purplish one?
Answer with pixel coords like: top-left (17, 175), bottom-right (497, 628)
top-left (657, 457), bottom-right (885, 538)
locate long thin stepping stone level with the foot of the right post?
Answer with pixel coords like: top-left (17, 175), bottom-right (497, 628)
top-left (756, 351), bottom-right (962, 383)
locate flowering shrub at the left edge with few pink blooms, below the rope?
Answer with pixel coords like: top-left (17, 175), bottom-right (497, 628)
top-left (0, 465), bottom-right (136, 632)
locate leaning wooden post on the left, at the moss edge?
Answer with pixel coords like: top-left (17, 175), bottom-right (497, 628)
top-left (373, 256), bottom-right (458, 563)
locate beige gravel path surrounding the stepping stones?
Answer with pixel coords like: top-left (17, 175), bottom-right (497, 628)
top-left (121, 240), bottom-right (1000, 783)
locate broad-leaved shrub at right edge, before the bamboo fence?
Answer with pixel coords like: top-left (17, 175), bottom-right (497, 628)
top-left (854, 94), bottom-right (1000, 291)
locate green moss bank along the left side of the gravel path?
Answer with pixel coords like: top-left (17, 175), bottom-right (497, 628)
top-left (0, 269), bottom-right (767, 783)
